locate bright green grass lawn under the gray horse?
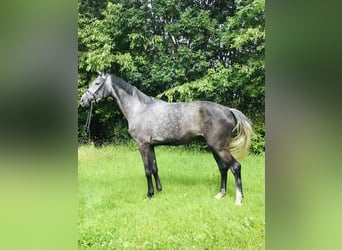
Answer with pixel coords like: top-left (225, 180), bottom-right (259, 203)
top-left (78, 146), bottom-right (265, 249)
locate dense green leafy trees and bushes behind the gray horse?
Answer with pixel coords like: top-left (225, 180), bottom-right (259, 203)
top-left (78, 0), bottom-right (265, 152)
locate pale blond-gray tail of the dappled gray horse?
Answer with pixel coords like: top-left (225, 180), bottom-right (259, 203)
top-left (229, 108), bottom-right (254, 160)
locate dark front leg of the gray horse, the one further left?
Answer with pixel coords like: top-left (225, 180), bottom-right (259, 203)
top-left (139, 144), bottom-right (154, 198)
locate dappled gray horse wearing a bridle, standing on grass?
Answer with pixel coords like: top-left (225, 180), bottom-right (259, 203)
top-left (81, 73), bottom-right (253, 205)
